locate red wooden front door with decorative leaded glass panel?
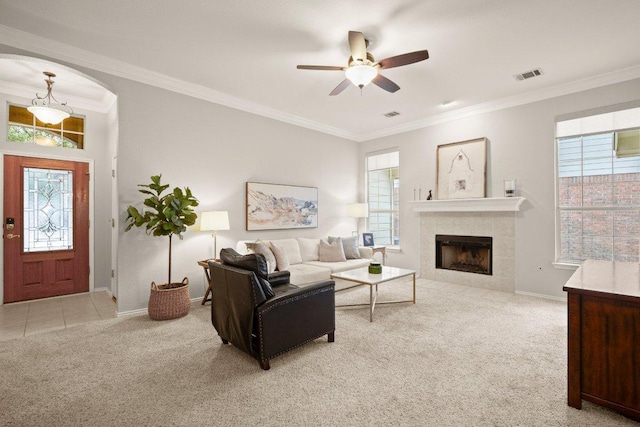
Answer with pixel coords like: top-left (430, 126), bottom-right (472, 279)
top-left (3, 156), bottom-right (89, 303)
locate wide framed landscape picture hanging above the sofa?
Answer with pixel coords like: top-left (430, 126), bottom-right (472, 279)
top-left (246, 182), bottom-right (318, 231)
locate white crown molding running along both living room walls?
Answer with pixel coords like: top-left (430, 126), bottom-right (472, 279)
top-left (0, 25), bottom-right (640, 142)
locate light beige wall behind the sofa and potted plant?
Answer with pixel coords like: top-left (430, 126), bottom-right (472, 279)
top-left (0, 45), bottom-right (358, 313)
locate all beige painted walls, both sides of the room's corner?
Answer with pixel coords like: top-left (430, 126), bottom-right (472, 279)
top-left (0, 45), bottom-right (640, 312)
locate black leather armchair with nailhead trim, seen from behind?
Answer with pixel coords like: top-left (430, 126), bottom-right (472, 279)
top-left (209, 249), bottom-right (335, 370)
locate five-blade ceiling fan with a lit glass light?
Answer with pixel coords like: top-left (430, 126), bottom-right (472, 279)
top-left (297, 31), bottom-right (429, 96)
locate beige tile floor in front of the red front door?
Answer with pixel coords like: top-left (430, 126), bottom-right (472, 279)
top-left (0, 291), bottom-right (116, 341)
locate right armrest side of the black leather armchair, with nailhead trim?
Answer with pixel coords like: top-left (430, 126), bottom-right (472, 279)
top-left (256, 280), bottom-right (336, 363)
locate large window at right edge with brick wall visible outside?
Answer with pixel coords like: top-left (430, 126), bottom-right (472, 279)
top-left (556, 109), bottom-right (640, 264)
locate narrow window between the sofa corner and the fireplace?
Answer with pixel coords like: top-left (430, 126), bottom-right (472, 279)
top-left (366, 150), bottom-right (400, 245)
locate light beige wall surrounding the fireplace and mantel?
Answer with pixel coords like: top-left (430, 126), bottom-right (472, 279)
top-left (360, 79), bottom-right (640, 298)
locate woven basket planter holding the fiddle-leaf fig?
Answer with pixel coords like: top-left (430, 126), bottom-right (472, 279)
top-left (149, 277), bottom-right (191, 320)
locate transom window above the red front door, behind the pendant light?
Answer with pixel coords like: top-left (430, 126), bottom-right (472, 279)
top-left (7, 104), bottom-right (84, 149)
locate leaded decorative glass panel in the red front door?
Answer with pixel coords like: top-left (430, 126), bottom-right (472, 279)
top-left (22, 168), bottom-right (73, 252)
